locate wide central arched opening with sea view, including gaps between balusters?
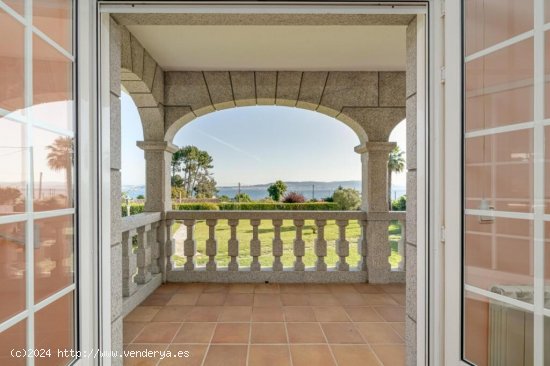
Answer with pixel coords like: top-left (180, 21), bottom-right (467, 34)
top-left (172, 106), bottom-right (362, 268)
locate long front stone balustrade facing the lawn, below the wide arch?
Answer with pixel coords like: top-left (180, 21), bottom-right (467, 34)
top-left (164, 211), bottom-right (406, 282)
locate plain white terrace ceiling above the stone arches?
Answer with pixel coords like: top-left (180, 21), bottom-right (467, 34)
top-left (128, 25), bottom-right (406, 71)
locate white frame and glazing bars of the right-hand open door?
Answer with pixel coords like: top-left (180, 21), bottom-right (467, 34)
top-left (441, 0), bottom-right (550, 366)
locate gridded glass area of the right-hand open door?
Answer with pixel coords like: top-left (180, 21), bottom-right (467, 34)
top-left (462, 0), bottom-right (550, 366)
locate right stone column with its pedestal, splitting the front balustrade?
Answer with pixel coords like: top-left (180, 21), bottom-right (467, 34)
top-left (355, 141), bottom-right (396, 283)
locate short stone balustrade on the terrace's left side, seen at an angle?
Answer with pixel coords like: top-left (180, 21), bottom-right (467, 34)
top-left (121, 212), bottom-right (164, 315)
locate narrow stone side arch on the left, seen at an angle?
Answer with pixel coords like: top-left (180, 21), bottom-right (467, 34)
top-left (120, 26), bottom-right (164, 140)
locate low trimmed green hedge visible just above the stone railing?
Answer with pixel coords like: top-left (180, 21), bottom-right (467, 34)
top-left (122, 202), bottom-right (339, 217)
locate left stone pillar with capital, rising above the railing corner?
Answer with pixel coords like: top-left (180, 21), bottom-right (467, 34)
top-left (137, 141), bottom-right (178, 212)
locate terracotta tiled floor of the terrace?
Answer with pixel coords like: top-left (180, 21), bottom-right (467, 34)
top-left (124, 283), bottom-right (405, 366)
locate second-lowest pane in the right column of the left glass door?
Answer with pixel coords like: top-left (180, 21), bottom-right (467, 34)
top-left (34, 216), bottom-right (74, 302)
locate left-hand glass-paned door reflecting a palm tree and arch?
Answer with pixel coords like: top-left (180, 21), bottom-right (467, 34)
top-left (0, 0), bottom-right (77, 365)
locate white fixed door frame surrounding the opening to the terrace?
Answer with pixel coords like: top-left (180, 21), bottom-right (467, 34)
top-left (97, 0), bottom-right (438, 365)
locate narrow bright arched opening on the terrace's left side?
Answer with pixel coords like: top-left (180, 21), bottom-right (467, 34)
top-left (120, 91), bottom-right (145, 209)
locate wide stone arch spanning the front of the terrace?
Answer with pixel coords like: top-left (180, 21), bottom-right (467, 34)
top-left (164, 71), bottom-right (405, 145)
